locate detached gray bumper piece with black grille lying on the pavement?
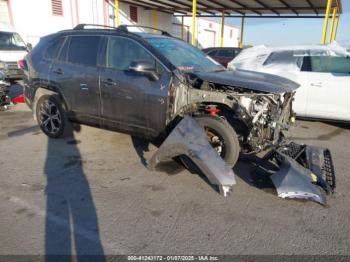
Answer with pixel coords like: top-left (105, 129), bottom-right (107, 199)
top-left (263, 142), bottom-right (335, 205)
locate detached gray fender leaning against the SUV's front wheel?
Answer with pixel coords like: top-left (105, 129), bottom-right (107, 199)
top-left (148, 116), bottom-right (236, 196)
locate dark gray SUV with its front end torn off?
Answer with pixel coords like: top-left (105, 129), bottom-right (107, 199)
top-left (25, 24), bottom-right (334, 205)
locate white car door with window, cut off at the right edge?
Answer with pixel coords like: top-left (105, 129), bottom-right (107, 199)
top-left (307, 55), bottom-right (350, 120)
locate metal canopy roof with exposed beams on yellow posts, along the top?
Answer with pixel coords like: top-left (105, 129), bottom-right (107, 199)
top-left (120, 0), bottom-right (342, 18)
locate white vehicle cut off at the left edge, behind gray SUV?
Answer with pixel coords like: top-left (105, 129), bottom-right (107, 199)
top-left (0, 31), bottom-right (31, 80)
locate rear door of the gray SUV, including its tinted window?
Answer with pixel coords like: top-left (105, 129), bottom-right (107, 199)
top-left (50, 35), bottom-right (102, 124)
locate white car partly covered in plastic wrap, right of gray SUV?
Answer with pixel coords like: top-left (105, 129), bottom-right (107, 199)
top-left (229, 44), bottom-right (350, 121)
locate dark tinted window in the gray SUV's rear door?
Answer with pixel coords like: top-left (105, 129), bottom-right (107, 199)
top-left (67, 36), bottom-right (101, 66)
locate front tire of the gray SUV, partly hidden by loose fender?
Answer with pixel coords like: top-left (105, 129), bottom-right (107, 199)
top-left (195, 116), bottom-right (241, 167)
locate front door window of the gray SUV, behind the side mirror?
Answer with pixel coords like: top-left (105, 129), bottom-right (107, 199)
top-left (106, 37), bottom-right (163, 73)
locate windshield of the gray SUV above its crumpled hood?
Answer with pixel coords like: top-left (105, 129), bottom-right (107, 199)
top-left (147, 37), bottom-right (225, 72)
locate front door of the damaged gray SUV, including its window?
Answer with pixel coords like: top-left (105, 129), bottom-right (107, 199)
top-left (100, 36), bottom-right (171, 136)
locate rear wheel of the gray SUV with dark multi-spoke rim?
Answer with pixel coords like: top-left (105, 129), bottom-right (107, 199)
top-left (35, 95), bottom-right (73, 138)
